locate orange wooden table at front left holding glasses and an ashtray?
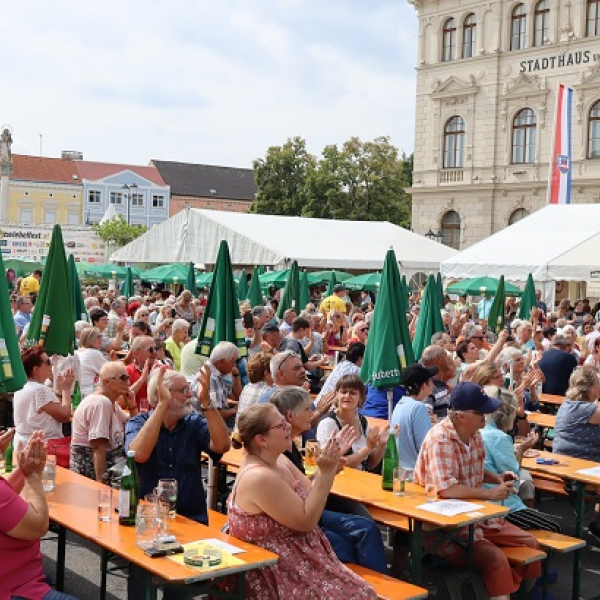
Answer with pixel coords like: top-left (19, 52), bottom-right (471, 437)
top-left (47, 467), bottom-right (278, 599)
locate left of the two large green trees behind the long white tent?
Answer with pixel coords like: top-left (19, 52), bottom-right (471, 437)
top-left (250, 137), bottom-right (317, 216)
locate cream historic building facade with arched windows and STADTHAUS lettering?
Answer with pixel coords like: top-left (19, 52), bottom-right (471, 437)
top-left (408, 0), bottom-right (600, 249)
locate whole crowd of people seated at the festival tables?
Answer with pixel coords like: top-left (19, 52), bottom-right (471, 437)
top-left (0, 273), bottom-right (600, 600)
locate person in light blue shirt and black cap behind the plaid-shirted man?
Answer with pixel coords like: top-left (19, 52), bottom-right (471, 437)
top-left (390, 363), bottom-right (438, 469)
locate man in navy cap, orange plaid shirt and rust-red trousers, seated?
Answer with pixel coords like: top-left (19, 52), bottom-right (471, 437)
top-left (415, 382), bottom-right (541, 600)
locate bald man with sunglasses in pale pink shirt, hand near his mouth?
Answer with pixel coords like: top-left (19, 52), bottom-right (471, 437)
top-left (71, 361), bottom-right (139, 481)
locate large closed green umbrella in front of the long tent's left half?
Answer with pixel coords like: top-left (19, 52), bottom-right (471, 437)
top-left (196, 240), bottom-right (247, 356)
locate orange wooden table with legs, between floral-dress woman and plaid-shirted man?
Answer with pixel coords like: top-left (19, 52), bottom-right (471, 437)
top-left (216, 446), bottom-right (508, 585)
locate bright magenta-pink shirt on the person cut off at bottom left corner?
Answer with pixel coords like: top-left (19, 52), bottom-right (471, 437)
top-left (0, 477), bottom-right (50, 600)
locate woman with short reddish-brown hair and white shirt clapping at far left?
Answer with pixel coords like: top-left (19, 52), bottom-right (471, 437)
top-left (13, 346), bottom-right (75, 452)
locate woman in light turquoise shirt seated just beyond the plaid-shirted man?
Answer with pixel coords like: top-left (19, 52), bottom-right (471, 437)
top-left (481, 385), bottom-right (560, 533)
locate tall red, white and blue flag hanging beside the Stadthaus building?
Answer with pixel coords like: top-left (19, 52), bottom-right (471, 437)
top-left (548, 84), bottom-right (573, 204)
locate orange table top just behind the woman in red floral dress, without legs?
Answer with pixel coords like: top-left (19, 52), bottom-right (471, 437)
top-left (221, 448), bottom-right (508, 527)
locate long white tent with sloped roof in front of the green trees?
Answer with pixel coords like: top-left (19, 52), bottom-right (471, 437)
top-left (111, 208), bottom-right (456, 277)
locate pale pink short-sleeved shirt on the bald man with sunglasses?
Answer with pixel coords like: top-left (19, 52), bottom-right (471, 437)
top-left (71, 394), bottom-right (129, 450)
